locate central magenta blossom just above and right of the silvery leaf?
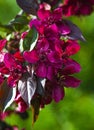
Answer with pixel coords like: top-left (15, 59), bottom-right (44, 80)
top-left (23, 43), bottom-right (62, 80)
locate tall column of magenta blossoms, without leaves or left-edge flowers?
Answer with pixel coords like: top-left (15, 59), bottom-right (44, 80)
top-left (23, 3), bottom-right (81, 107)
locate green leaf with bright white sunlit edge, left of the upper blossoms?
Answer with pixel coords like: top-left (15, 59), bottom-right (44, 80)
top-left (23, 27), bottom-right (38, 51)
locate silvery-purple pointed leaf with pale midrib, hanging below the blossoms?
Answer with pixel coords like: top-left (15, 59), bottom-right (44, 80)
top-left (18, 73), bottom-right (36, 106)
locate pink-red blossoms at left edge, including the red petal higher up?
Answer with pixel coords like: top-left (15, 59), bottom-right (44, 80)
top-left (0, 39), bottom-right (25, 87)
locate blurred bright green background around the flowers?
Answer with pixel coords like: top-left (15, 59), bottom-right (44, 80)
top-left (0, 0), bottom-right (94, 130)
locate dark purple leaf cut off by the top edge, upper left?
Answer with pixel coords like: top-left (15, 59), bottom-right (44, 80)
top-left (16, 0), bottom-right (39, 15)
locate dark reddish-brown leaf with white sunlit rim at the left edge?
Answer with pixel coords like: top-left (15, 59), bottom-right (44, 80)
top-left (0, 80), bottom-right (16, 111)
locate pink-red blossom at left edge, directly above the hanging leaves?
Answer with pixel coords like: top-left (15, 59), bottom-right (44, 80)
top-left (0, 53), bottom-right (26, 87)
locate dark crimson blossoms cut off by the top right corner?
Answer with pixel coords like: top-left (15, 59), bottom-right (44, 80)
top-left (63, 0), bottom-right (94, 16)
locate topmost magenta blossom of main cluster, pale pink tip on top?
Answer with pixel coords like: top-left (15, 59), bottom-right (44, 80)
top-left (29, 3), bottom-right (70, 35)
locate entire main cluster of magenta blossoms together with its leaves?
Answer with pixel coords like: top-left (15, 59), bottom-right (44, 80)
top-left (0, 1), bottom-right (84, 124)
